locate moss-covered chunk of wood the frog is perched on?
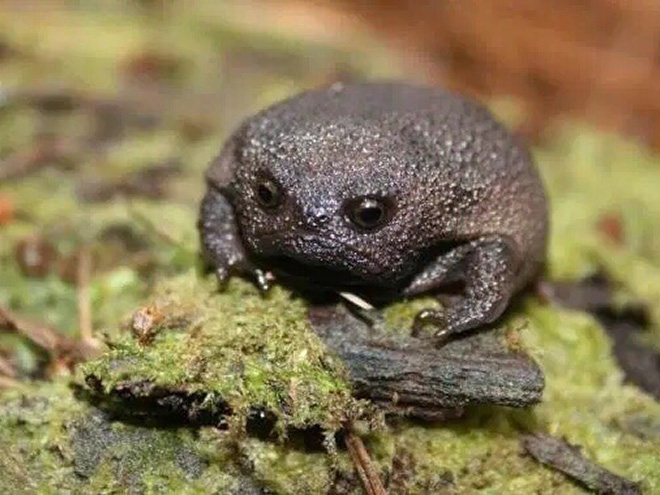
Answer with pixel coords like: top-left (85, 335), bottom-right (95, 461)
top-left (80, 273), bottom-right (543, 434)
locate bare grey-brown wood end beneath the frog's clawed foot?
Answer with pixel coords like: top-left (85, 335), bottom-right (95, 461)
top-left (309, 305), bottom-right (544, 419)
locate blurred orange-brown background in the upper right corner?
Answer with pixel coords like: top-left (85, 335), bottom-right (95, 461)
top-left (306, 0), bottom-right (660, 149)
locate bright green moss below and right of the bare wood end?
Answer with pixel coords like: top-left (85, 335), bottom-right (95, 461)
top-left (354, 308), bottom-right (660, 494)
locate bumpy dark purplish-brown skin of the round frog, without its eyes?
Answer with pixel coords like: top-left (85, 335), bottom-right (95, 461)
top-left (200, 83), bottom-right (548, 337)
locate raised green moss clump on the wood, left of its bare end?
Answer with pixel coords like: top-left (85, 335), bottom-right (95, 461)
top-left (83, 273), bottom-right (363, 428)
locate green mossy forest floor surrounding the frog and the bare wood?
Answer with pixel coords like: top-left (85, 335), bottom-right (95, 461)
top-left (0, 1), bottom-right (660, 494)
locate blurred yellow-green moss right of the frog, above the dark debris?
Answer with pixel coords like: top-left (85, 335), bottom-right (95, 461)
top-left (535, 125), bottom-right (660, 345)
